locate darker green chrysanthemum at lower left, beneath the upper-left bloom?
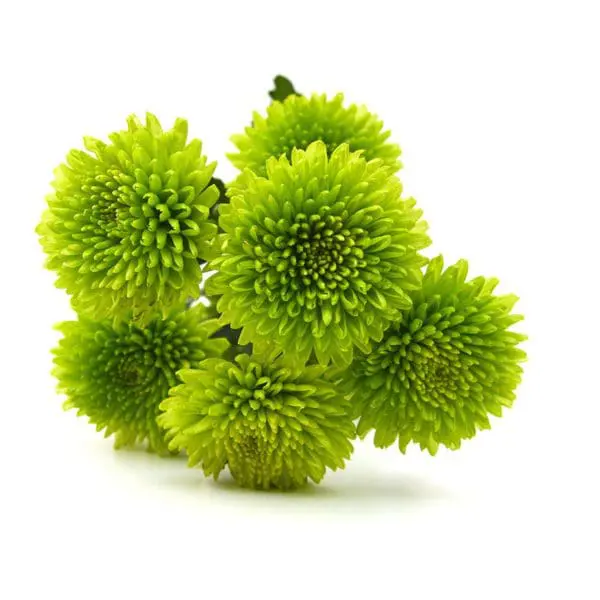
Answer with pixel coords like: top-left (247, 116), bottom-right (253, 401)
top-left (53, 304), bottom-right (229, 454)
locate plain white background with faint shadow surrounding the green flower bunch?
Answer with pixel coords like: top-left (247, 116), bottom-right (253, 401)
top-left (0, 0), bottom-right (600, 600)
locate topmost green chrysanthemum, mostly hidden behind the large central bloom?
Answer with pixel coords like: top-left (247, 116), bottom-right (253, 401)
top-left (229, 94), bottom-right (401, 176)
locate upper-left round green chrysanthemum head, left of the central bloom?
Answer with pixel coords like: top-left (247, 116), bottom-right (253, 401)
top-left (37, 114), bottom-right (219, 320)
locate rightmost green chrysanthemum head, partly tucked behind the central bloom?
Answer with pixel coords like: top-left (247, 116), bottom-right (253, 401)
top-left (345, 257), bottom-right (525, 454)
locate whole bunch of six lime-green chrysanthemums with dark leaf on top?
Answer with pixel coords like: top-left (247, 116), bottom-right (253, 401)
top-left (37, 77), bottom-right (525, 490)
